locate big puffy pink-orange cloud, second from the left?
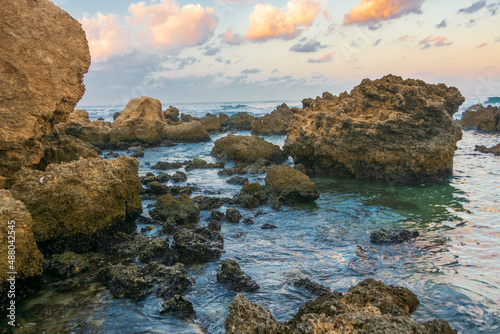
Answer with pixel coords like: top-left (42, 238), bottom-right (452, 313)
top-left (127, 0), bottom-right (219, 50)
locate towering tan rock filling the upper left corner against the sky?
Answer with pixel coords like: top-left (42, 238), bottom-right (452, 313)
top-left (0, 0), bottom-right (90, 188)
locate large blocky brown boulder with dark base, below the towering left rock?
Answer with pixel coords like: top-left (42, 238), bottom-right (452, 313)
top-left (11, 156), bottom-right (142, 254)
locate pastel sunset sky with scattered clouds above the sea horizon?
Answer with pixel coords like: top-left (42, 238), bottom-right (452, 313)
top-left (49, 0), bottom-right (500, 106)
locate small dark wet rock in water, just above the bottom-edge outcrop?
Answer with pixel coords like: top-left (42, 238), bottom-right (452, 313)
top-left (217, 260), bottom-right (260, 292)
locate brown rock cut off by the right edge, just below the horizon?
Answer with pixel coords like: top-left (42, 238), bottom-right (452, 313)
top-left (460, 104), bottom-right (500, 132)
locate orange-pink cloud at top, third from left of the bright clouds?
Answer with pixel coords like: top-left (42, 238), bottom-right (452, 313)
top-left (245, 0), bottom-right (321, 42)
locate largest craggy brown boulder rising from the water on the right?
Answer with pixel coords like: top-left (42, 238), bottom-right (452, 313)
top-left (285, 75), bottom-right (465, 184)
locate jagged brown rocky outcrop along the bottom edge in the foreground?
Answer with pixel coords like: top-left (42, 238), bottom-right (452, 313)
top-left (225, 279), bottom-right (456, 334)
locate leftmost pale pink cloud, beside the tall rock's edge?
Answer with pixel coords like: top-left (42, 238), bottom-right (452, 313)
top-left (81, 13), bottom-right (132, 61)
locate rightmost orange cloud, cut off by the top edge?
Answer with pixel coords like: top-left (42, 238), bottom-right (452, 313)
top-left (344, 0), bottom-right (424, 24)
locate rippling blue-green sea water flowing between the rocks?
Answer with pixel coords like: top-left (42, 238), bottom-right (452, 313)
top-left (8, 99), bottom-right (500, 333)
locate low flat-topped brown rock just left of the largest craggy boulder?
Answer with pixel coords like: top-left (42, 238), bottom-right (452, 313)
top-left (211, 134), bottom-right (287, 165)
